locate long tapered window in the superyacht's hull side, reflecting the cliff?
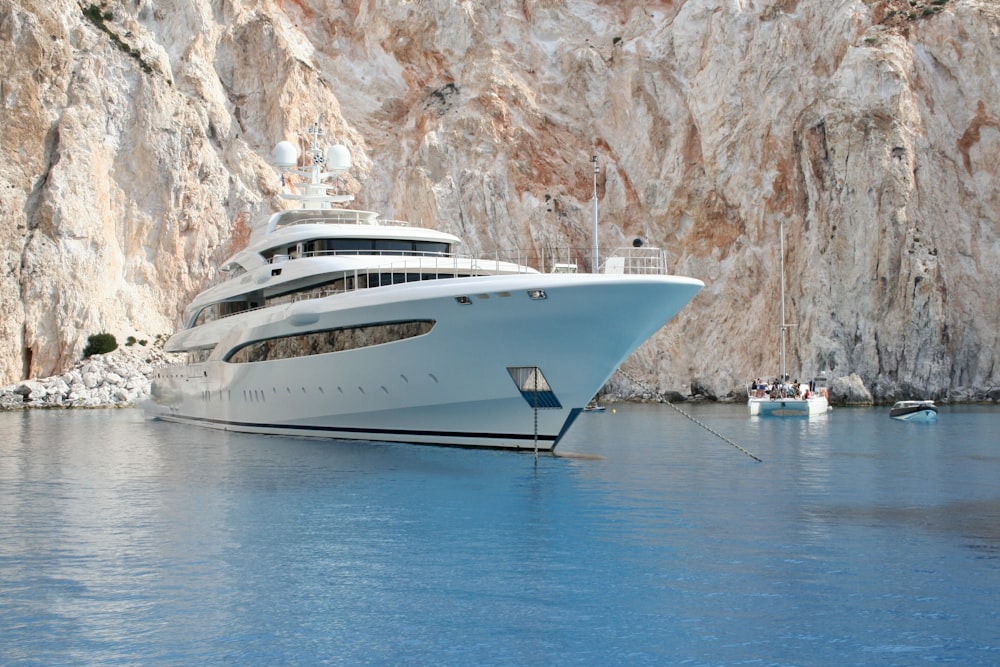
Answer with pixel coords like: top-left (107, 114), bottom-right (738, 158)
top-left (225, 320), bottom-right (434, 364)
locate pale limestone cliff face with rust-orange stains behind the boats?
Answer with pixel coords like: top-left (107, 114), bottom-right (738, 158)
top-left (0, 0), bottom-right (1000, 400)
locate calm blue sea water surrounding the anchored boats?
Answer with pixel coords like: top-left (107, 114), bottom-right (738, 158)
top-left (0, 404), bottom-right (1000, 666)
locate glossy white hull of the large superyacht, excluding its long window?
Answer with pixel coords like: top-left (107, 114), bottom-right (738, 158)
top-left (152, 274), bottom-right (702, 451)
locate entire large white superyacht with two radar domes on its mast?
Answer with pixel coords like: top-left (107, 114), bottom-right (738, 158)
top-left (152, 127), bottom-right (703, 451)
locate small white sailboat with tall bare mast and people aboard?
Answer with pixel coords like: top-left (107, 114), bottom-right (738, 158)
top-left (747, 223), bottom-right (830, 417)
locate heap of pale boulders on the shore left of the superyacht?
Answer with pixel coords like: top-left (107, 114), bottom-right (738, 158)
top-left (0, 345), bottom-right (183, 410)
